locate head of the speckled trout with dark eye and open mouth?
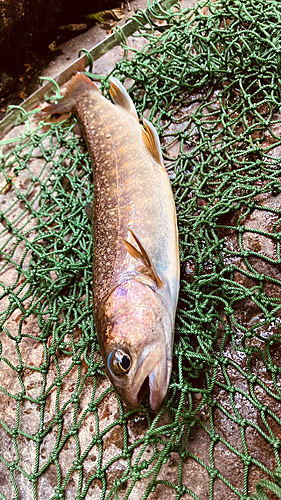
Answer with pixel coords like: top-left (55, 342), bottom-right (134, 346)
top-left (98, 283), bottom-right (172, 410)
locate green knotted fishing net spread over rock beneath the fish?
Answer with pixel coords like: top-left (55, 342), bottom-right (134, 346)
top-left (0, 0), bottom-right (281, 500)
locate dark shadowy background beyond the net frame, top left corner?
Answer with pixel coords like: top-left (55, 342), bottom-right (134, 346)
top-left (0, 0), bottom-right (121, 119)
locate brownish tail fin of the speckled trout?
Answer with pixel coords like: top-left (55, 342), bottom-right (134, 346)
top-left (43, 72), bottom-right (99, 114)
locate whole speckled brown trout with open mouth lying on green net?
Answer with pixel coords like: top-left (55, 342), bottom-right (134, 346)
top-left (44, 73), bottom-right (180, 411)
